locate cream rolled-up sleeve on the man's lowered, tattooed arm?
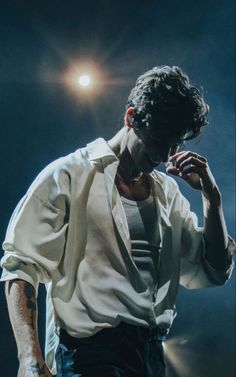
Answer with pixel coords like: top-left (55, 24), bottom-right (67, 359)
top-left (1, 184), bottom-right (67, 290)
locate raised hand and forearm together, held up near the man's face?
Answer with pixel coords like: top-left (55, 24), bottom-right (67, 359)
top-left (167, 151), bottom-right (231, 272)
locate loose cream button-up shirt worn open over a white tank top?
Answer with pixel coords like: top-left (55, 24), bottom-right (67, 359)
top-left (1, 139), bottom-right (234, 372)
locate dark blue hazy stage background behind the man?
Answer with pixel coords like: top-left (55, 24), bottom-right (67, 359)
top-left (0, 0), bottom-right (235, 377)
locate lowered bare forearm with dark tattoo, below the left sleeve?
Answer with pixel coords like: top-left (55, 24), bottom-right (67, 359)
top-left (6, 280), bottom-right (43, 364)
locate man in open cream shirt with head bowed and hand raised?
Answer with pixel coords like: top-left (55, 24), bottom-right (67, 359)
top-left (2, 66), bottom-right (233, 377)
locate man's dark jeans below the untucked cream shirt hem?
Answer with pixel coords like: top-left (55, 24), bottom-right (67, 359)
top-left (56, 323), bottom-right (165, 377)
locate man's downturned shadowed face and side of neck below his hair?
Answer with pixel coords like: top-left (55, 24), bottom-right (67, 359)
top-left (126, 128), bottom-right (184, 173)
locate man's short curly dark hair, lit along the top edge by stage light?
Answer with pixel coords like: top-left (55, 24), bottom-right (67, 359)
top-left (126, 66), bottom-right (209, 140)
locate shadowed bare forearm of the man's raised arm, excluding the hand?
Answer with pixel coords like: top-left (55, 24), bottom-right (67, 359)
top-left (202, 187), bottom-right (229, 270)
